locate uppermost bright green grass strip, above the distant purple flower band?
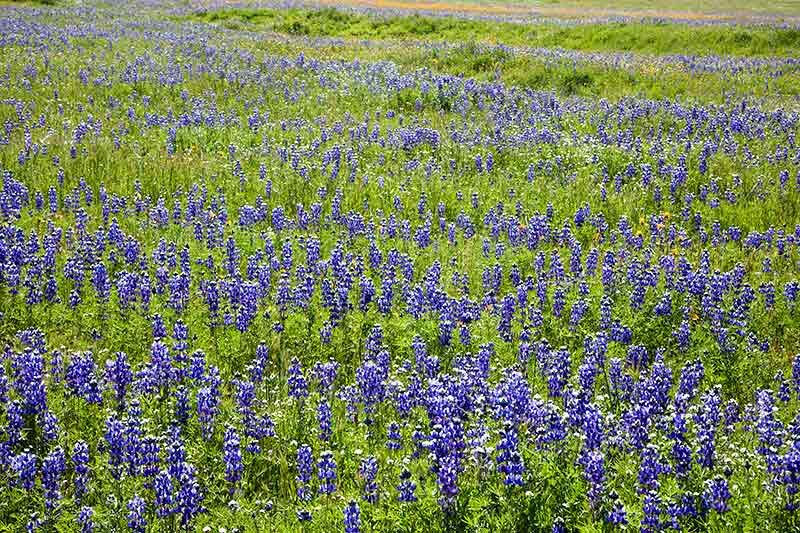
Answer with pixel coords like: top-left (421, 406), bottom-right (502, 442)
top-left (189, 8), bottom-right (800, 56)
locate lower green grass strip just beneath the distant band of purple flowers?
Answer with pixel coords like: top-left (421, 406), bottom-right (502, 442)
top-left (180, 24), bottom-right (800, 107)
